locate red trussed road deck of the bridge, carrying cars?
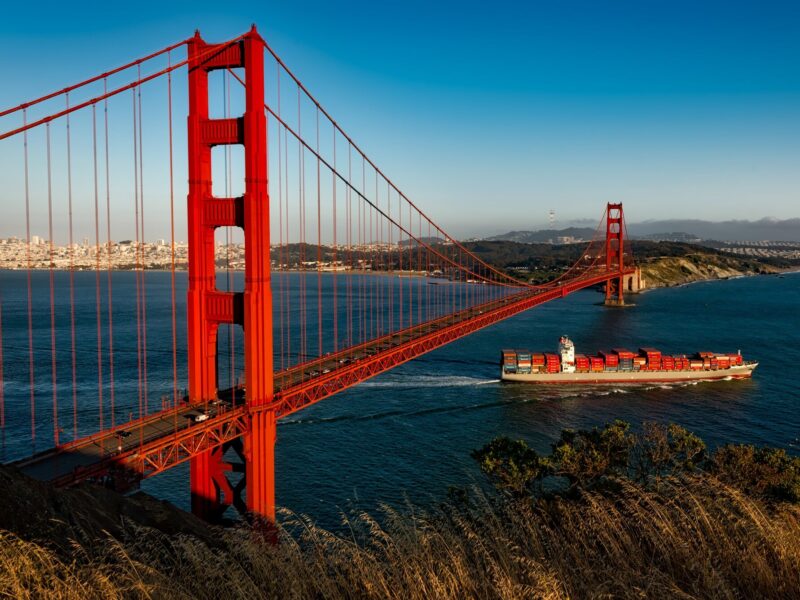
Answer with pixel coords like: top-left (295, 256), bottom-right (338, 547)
top-left (13, 271), bottom-right (627, 487)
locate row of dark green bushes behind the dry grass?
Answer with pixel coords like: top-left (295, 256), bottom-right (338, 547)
top-left (472, 420), bottom-right (800, 503)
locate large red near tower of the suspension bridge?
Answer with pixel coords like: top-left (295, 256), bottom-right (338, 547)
top-left (187, 27), bottom-right (276, 520)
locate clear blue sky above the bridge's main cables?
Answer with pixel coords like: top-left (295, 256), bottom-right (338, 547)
top-left (0, 0), bottom-right (800, 236)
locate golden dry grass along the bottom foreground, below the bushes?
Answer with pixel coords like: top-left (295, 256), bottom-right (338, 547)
top-left (0, 477), bottom-right (800, 600)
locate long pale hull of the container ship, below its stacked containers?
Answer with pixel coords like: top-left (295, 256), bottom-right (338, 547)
top-left (500, 363), bottom-right (758, 385)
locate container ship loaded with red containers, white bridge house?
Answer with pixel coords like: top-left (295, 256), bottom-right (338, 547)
top-left (500, 336), bottom-right (758, 384)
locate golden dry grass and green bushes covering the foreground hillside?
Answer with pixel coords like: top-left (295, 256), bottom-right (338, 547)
top-left (0, 422), bottom-right (800, 599)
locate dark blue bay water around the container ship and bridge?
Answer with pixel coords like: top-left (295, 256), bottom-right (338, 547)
top-left (0, 271), bottom-right (800, 527)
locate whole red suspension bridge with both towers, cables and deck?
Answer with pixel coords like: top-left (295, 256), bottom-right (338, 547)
top-left (0, 27), bottom-right (633, 520)
